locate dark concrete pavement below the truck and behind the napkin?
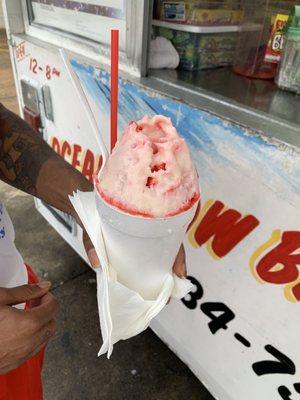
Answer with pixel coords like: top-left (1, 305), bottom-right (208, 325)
top-left (0, 32), bottom-right (213, 400)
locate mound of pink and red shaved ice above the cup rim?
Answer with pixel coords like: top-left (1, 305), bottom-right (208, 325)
top-left (95, 115), bottom-right (199, 218)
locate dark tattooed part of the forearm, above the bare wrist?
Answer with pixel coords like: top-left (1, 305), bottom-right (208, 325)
top-left (0, 104), bottom-right (59, 195)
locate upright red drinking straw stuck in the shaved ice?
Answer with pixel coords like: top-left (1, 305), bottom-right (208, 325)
top-left (110, 29), bottom-right (119, 151)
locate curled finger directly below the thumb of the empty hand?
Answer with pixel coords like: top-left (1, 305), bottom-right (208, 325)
top-left (25, 293), bottom-right (59, 331)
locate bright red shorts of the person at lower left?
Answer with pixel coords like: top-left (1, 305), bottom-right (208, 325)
top-left (0, 266), bottom-right (44, 400)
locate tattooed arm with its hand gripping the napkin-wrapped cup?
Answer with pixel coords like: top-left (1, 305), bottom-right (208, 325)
top-left (0, 104), bottom-right (99, 266)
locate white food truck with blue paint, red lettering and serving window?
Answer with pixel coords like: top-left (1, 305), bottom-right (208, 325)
top-left (3, 0), bottom-right (300, 400)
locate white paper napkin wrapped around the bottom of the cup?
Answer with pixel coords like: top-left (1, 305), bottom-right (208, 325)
top-left (70, 191), bottom-right (192, 358)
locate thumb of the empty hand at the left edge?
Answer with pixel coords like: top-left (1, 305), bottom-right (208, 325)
top-left (0, 281), bottom-right (51, 305)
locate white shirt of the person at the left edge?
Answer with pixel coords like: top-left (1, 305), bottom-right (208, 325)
top-left (0, 203), bottom-right (28, 296)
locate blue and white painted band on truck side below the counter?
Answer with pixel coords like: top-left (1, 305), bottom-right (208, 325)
top-left (72, 60), bottom-right (300, 205)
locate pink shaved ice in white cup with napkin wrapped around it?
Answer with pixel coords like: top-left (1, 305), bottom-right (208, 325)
top-left (71, 116), bottom-right (200, 357)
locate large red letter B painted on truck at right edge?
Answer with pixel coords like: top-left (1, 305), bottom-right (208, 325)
top-left (256, 231), bottom-right (300, 286)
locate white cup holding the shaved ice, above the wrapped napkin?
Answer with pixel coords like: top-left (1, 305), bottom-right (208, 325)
top-left (95, 191), bottom-right (198, 300)
